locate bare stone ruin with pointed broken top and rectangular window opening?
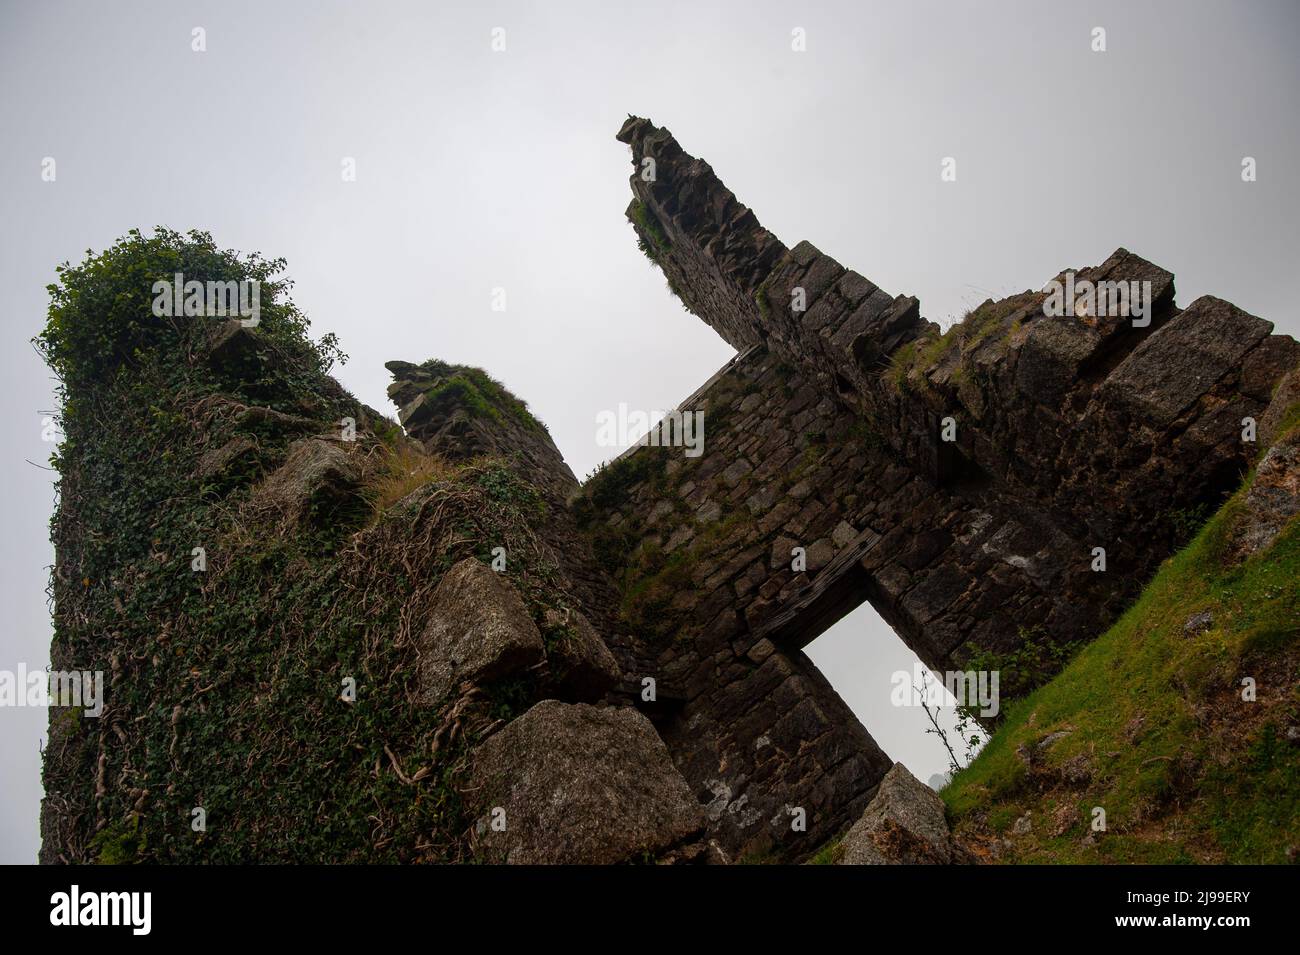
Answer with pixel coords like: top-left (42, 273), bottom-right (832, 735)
top-left (389, 117), bottom-right (1300, 860)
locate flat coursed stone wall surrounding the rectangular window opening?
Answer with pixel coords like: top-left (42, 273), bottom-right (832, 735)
top-left (577, 348), bottom-right (1114, 855)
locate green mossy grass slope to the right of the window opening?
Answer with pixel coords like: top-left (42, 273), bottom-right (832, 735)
top-left (943, 441), bottom-right (1300, 863)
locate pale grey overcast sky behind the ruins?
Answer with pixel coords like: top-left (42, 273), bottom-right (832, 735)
top-left (0, 0), bottom-right (1300, 861)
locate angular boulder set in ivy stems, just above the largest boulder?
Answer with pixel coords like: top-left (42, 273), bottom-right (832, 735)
top-left (417, 557), bottom-right (545, 706)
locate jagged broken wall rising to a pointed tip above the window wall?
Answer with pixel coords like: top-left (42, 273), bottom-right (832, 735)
top-left (619, 118), bottom-right (1300, 566)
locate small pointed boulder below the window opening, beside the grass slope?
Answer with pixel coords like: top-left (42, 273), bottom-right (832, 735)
top-left (839, 763), bottom-right (953, 865)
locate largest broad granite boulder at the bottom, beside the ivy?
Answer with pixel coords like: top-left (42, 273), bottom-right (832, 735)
top-left (465, 700), bottom-right (705, 865)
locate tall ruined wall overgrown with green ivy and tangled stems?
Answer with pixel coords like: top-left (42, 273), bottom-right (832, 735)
top-left (38, 230), bottom-right (647, 863)
